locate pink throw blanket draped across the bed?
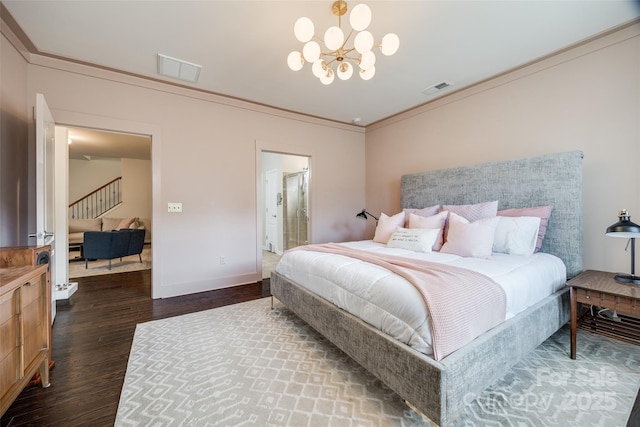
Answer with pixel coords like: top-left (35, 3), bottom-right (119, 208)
top-left (293, 243), bottom-right (506, 360)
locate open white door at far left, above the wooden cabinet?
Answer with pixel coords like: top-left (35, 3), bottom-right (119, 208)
top-left (35, 93), bottom-right (56, 321)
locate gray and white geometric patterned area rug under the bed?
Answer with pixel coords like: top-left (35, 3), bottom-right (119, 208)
top-left (115, 298), bottom-right (640, 427)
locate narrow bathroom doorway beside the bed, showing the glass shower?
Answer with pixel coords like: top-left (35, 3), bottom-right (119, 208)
top-left (261, 151), bottom-right (311, 279)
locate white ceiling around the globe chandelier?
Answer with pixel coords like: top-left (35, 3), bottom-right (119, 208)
top-left (3, 0), bottom-right (640, 130)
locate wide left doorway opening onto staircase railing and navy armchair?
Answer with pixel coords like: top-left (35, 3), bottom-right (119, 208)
top-left (65, 126), bottom-right (152, 279)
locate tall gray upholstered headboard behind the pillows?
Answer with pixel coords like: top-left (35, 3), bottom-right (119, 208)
top-left (401, 151), bottom-right (583, 278)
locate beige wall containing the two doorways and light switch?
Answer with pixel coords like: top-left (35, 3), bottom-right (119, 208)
top-left (22, 50), bottom-right (365, 297)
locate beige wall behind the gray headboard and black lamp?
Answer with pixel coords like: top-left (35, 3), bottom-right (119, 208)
top-left (366, 24), bottom-right (640, 272)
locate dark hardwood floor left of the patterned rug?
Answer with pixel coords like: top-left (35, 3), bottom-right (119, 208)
top-left (0, 270), bottom-right (269, 427)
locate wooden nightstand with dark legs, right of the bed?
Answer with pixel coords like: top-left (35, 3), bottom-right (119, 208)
top-left (567, 270), bottom-right (640, 359)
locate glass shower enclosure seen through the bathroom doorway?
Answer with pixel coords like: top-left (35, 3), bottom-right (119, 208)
top-left (282, 170), bottom-right (309, 250)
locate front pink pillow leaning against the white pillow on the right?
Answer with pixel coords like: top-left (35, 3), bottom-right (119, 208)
top-left (440, 212), bottom-right (500, 258)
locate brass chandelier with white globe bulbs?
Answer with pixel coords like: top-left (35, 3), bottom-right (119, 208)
top-left (287, 0), bottom-right (400, 85)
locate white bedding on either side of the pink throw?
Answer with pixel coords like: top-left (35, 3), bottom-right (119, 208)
top-left (276, 240), bottom-right (566, 355)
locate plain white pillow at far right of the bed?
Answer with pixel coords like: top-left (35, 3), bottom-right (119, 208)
top-left (493, 216), bottom-right (540, 255)
